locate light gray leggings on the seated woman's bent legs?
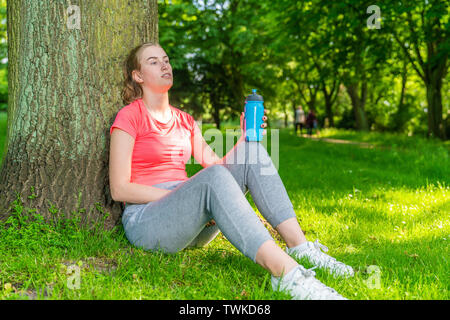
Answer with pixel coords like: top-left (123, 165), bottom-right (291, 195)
top-left (122, 141), bottom-right (296, 261)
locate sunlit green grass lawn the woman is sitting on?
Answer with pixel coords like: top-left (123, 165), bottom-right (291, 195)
top-left (0, 115), bottom-right (450, 299)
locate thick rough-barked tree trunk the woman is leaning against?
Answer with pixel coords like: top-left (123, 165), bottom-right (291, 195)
top-left (0, 0), bottom-right (158, 227)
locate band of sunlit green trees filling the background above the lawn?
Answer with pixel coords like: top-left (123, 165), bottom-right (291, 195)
top-left (159, 0), bottom-right (450, 139)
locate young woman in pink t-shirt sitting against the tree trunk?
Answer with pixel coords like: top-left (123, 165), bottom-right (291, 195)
top-left (109, 43), bottom-right (353, 299)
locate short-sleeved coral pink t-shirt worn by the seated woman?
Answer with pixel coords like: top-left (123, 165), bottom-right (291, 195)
top-left (109, 98), bottom-right (201, 186)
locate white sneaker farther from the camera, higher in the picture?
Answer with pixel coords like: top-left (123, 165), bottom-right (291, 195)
top-left (286, 240), bottom-right (355, 277)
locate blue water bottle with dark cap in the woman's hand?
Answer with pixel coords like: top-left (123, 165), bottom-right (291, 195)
top-left (244, 89), bottom-right (264, 141)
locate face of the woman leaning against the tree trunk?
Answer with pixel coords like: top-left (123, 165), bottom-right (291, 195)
top-left (133, 46), bottom-right (173, 93)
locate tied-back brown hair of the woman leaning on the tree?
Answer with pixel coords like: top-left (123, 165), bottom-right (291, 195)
top-left (122, 42), bottom-right (161, 105)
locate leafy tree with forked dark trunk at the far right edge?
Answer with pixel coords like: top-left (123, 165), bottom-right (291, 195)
top-left (382, 0), bottom-right (450, 139)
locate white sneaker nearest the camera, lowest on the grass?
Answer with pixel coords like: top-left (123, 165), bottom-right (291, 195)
top-left (272, 265), bottom-right (347, 300)
